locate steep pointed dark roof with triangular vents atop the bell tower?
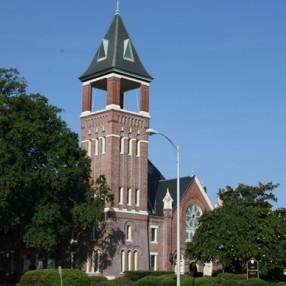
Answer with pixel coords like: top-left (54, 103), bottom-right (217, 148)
top-left (80, 10), bottom-right (153, 82)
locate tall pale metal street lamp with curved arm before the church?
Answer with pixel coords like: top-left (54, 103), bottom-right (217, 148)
top-left (146, 128), bottom-right (181, 286)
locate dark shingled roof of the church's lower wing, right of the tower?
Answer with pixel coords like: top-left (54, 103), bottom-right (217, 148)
top-left (148, 161), bottom-right (195, 215)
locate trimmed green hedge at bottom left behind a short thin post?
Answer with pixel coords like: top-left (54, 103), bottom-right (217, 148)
top-left (17, 269), bottom-right (90, 286)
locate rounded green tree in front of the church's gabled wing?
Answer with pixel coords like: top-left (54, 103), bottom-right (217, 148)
top-left (186, 183), bottom-right (286, 272)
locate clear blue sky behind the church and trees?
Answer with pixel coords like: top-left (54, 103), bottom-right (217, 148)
top-left (0, 0), bottom-right (286, 207)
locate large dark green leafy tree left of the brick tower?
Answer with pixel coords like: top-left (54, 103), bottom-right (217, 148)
top-left (0, 69), bottom-right (112, 255)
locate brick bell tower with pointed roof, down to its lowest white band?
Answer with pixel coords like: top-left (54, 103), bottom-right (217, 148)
top-left (80, 8), bottom-right (152, 214)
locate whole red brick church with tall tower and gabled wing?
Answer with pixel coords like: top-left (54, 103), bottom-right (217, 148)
top-left (80, 4), bottom-right (217, 278)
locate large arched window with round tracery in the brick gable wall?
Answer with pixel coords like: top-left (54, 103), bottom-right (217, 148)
top-left (186, 204), bottom-right (203, 241)
